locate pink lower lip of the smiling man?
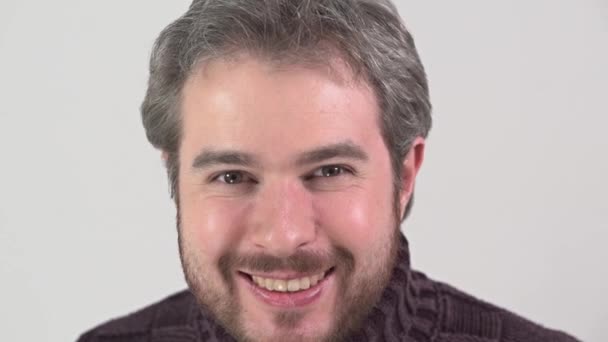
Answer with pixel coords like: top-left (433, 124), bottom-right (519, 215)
top-left (239, 272), bottom-right (334, 309)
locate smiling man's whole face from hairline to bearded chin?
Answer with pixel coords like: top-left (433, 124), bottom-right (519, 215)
top-left (178, 57), bottom-right (398, 341)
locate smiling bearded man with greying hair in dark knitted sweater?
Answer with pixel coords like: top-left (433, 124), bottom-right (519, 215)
top-left (80, 0), bottom-right (575, 342)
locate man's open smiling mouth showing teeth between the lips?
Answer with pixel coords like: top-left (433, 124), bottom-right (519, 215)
top-left (239, 267), bottom-right (334, 293)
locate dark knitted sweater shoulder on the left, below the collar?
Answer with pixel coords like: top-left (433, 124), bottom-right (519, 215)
top-left (77, 290), bottom-right (195, 342)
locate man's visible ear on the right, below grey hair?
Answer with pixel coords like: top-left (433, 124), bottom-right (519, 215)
top-left (399, 137), bottom-right (425, 217)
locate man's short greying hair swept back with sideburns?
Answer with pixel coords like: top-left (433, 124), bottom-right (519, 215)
top-left (141, 0), bottom-right (431, 220)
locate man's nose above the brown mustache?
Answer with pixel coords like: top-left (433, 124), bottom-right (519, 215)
top-left (250, 180), bottom-right (317, 257)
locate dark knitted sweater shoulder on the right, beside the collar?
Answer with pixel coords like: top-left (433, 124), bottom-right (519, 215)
top-left (436, 282), bottom-right (579, 342)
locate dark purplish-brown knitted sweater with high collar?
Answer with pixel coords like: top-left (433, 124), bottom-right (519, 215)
top-left (78, 236), bottom-right (577, 342)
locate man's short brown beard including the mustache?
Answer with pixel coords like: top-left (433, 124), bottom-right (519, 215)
top-left (177, 210), bottom-right (400, 341)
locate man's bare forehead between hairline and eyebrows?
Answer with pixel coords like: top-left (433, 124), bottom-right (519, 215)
top-left (180, 57), bottom-right (380, 163)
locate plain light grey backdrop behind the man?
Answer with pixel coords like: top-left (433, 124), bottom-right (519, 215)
top-left (0, 0), bottom-right (608, 342)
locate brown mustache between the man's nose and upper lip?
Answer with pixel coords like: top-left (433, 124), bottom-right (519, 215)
top-left (218, 247), bottom-right (355, 279)
